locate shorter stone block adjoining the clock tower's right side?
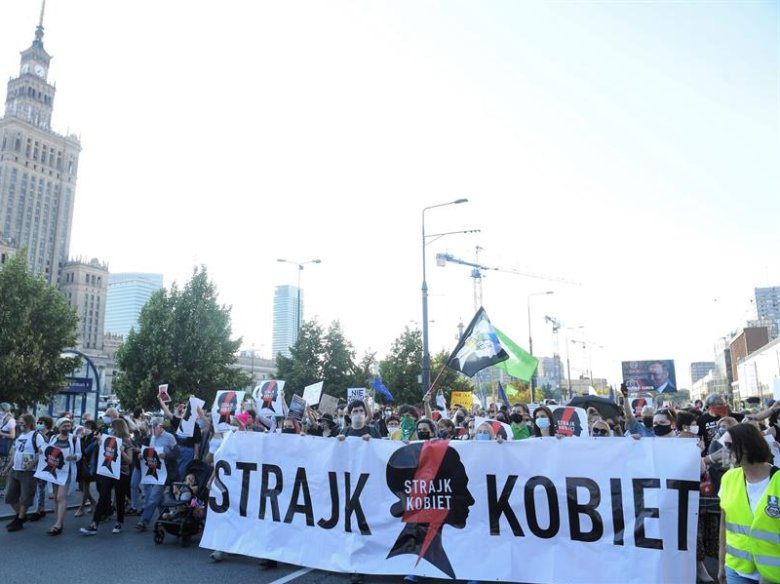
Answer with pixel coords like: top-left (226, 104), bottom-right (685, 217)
top-left (59, 259), bottom-right (108, 351)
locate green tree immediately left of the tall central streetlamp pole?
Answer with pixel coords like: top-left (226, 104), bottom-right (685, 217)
top-left (379, 326), bottom-right (422, 404)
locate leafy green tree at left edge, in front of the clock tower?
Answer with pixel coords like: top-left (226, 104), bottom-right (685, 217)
top-left (0, 249), bottom-right (80, 410)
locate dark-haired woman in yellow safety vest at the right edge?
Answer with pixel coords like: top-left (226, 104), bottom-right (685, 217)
top-left (718, 424), bottom-right (780, 584)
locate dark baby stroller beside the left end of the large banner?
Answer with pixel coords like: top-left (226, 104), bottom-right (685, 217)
top-left (154, 460), bottom-right (213, 547)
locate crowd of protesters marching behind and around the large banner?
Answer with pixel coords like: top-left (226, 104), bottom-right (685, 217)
top-left (0, 390), bottom-right (780, 583)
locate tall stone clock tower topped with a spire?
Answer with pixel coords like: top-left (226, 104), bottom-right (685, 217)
top-left (0, 13), bottom-right (81, 284)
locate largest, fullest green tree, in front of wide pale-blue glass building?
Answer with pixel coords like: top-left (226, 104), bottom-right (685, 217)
top-left (114, 266), bottom-right (251, 408)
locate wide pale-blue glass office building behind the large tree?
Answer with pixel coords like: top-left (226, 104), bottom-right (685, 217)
top-left (105, 272), bottom-right (163, 338)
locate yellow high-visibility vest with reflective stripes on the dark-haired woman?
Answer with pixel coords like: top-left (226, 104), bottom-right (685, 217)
top-left (720, 467), bottom-right (780, 582)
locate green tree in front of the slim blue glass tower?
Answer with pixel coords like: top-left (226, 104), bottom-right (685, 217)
top-left (276, 320), bottom-right (329, 397)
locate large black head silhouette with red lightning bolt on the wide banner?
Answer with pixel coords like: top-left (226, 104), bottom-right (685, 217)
top-left (387, 440), bottom-right (474, 579)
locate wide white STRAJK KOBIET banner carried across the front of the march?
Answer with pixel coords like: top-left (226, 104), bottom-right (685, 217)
top-left (200, 432), bottom-right (700, 584)
